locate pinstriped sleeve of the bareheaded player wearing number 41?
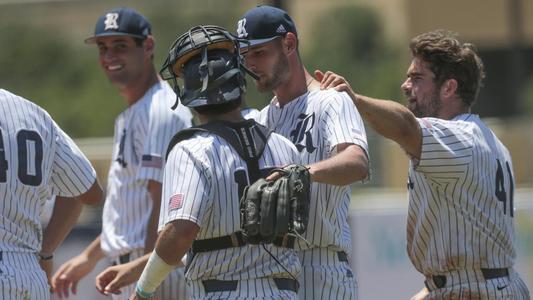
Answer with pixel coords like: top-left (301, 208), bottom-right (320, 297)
top-left (413, 118), bottom-right (475, 176)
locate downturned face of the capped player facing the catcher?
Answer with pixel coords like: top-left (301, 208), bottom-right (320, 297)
top-left (243, 39), bottom-right (290, 92)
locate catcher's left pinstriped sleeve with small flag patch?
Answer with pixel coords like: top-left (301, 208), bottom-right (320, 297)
top-left (159, 144), bottom-right (212, 230)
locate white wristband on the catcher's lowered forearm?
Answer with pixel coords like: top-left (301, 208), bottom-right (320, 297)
top-left (137, 250), bottom-right (174, 293)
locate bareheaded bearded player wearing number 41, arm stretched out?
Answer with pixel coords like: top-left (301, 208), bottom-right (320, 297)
top-left (317, 31), bottom-right (529, 299)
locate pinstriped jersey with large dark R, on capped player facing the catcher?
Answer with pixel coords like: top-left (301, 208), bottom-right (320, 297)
top-left (258, 90), bottom-right (368, 253)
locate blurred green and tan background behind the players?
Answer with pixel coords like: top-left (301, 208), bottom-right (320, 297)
top-left (0, 0), bottom-right (533, 300)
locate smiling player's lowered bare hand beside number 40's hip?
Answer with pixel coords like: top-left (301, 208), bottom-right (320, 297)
top-left (52, 254), bottom-right (97, 298)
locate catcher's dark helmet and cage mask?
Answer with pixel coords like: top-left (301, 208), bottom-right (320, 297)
top-left (160, 25), bottom-right (255, 109)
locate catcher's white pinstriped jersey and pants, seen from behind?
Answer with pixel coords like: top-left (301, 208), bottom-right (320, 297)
top-left (159, 120), bottom-right (301, 299)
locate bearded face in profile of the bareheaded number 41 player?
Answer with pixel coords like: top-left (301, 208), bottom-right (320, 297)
top-left (401, 57), bottom-right (442, 118)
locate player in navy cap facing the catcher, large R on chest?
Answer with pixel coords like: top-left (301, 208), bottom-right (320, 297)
top-left (237, 6), bottom-right (368, 300)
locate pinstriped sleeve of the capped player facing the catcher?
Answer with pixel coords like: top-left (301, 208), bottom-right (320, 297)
top-left (323, 91), bottom-right (368, 156)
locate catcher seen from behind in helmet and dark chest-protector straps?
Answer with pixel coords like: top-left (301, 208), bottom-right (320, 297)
top-left (131, 26), bottom-right (300, 299)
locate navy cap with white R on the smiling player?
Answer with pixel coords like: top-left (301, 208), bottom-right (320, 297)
top-left (85, 7), bottom-right (152, 44)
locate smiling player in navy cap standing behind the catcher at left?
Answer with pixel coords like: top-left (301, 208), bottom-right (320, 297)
top-left (53, 8), bottom-right (192, 299)
